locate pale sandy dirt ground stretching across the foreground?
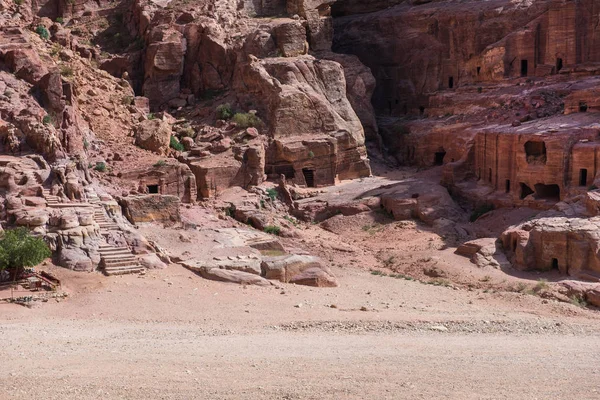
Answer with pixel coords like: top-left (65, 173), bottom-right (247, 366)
top-left (0, 266), bottom-right (600, 399)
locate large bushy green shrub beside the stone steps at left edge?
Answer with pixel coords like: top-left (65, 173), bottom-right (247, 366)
top-left (0, 228), bottom-right (52, 277)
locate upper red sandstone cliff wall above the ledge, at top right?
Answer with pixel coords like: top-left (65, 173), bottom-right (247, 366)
top-left (334, 0), bottom-right (600, 115)
